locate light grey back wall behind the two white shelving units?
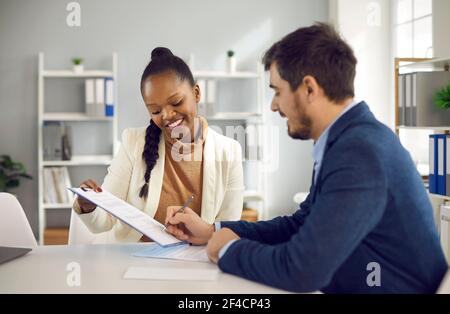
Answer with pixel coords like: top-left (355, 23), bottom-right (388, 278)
top-left (0, 0), bottom-right (328, 236)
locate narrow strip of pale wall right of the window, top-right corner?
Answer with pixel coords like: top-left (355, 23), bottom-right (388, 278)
top-left (433, 0), bottom-right (450, 58)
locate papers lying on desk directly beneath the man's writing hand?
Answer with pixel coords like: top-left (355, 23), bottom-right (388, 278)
top-left (133, 243), bottom-right (209, 262)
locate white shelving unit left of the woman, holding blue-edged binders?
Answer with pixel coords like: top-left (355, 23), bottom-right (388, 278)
top-left (37, 52), bottom-right (118, 244)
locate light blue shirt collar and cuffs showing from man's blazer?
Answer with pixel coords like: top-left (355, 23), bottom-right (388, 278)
top-left (214, 101), bottom-right (359, 259)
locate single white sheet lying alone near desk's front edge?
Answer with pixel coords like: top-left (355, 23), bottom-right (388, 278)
top-left (123, 266), bottom-right (219, 281)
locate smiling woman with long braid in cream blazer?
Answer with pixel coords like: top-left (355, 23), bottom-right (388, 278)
top-left (73, 47), bottom-right (244, 243)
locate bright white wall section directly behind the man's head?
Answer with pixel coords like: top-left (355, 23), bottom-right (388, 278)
top-left (329, 0), bottom-right (394, 128)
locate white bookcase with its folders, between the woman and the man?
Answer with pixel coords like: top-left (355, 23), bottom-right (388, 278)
top-left (193, 64), bottom-right (267, 219)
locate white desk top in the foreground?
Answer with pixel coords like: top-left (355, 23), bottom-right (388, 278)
top-left (0, 244), bottom-right (284, 294)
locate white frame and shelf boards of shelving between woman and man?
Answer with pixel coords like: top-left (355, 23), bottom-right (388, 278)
top-left (193, 64), bottom-right (268, 219)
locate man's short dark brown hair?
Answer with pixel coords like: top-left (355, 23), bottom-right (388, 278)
top-left (263, 23), bottom-right (357, 102)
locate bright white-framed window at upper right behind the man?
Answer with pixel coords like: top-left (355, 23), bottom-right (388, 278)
top-left (393, 0), bottom-right (433, 58)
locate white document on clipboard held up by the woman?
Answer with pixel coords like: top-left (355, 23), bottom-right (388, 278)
top-left (69, 188), bottom-right (185, 247)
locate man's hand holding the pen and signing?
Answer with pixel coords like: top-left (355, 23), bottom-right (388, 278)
top-left (166, 206), bottom-right (215, 245)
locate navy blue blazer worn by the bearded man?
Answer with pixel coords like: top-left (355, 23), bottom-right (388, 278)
top-left (219, 102), bottom-right (447, 293)
